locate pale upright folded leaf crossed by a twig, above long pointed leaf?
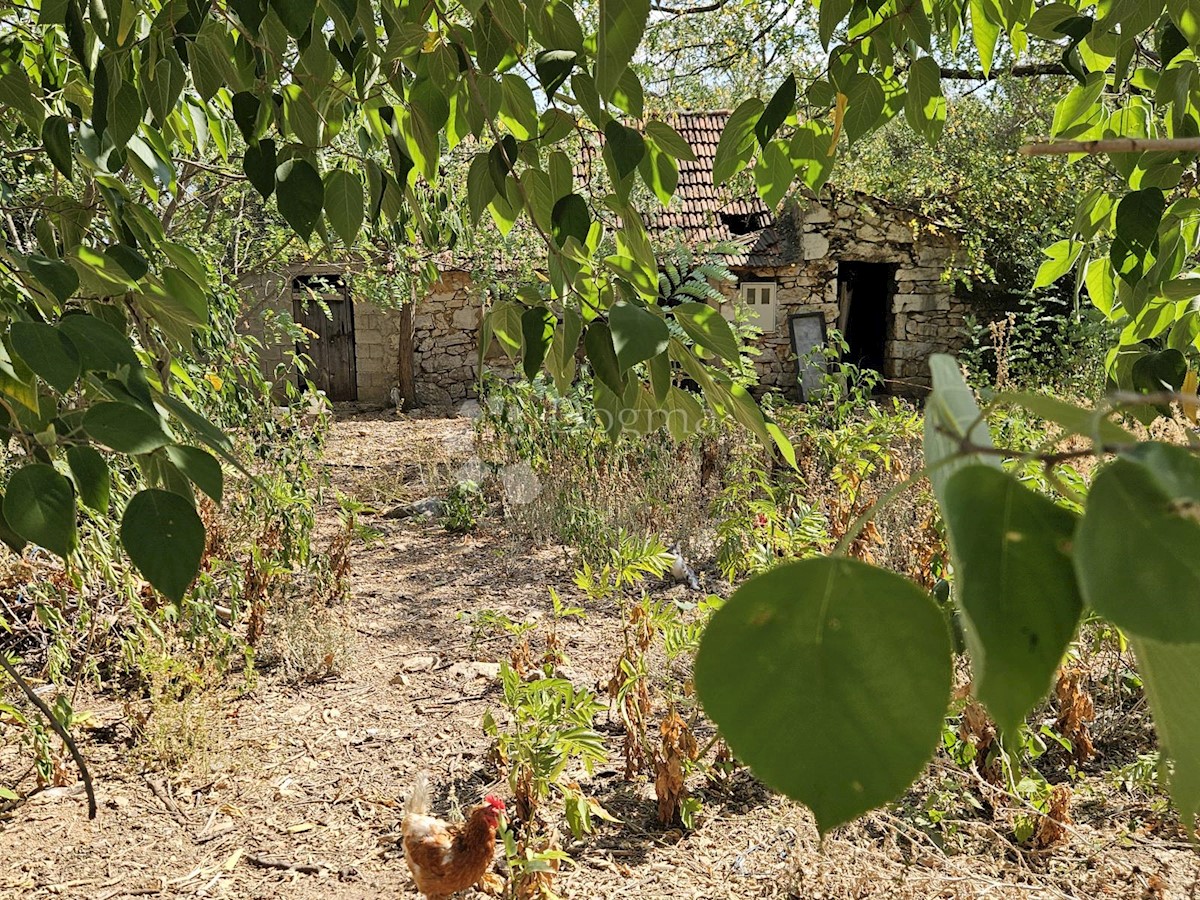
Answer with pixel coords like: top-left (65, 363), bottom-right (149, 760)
top-left (925, 353), bottom-right (1000, 510)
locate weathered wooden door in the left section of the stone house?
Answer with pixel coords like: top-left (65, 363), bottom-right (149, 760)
top-left (292, 275), bottom-right (359, 401)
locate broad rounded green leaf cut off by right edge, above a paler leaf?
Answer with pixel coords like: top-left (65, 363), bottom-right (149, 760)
top-left (1075, 443), bottom-right (1200, 643)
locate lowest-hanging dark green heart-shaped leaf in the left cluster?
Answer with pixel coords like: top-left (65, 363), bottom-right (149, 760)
top-left (121, 488), bottom-right (204, 604)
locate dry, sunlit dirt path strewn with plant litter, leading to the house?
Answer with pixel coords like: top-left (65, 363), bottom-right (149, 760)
top-left (0, 414), bottom-right (1198, 900)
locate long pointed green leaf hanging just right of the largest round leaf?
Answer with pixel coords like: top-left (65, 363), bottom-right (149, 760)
top-left (944, 466), bottom-right (1084, 736)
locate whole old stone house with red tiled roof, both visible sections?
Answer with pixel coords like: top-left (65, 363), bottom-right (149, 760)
top-left (245, 113), bottom-right (966, 406)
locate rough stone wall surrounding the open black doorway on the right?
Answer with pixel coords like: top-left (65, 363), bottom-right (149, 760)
top-left (722, 197), bottom-right (967, 392)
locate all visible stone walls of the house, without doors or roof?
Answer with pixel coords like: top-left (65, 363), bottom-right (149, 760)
top-left (242, 196), bottom-right (967, 406)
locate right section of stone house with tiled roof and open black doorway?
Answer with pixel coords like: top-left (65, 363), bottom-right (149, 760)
top-left (652, 113), bottom-right (967, 392)
